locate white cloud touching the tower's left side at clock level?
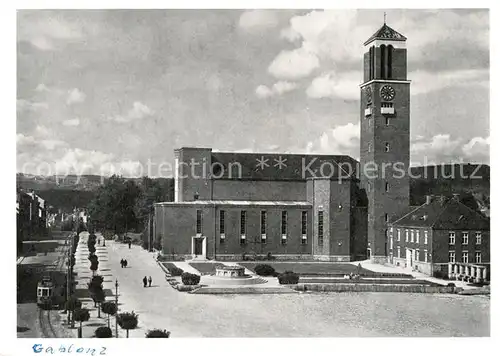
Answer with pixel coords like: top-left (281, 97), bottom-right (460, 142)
top-left (306, 71), bottom-right (362, 100)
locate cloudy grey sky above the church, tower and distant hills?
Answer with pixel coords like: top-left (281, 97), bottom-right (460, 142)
top-left (16, 9), bottom-right (490, 176)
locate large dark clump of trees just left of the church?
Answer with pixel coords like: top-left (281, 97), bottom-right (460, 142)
top-left (88, 175), bottom-right (174, 234)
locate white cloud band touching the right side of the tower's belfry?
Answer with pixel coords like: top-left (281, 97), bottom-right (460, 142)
top-left (408, 69), bottom-right (489, 95)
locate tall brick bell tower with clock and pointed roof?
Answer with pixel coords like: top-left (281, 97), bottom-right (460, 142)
top-left (360, 23), bottom-right (410, 263)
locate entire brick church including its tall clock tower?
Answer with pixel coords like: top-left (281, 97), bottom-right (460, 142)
top-left (153, 24), bottom-right (410, 262)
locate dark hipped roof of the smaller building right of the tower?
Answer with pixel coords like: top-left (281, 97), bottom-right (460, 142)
top-left (391, 197), bottom-right (490, 230)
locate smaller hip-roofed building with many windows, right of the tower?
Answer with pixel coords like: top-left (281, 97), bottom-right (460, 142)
top-left (389, 195), bottom-right (490, 274)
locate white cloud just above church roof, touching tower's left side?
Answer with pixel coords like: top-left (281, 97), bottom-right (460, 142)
top-left (306, 123), bottom-right (360, 158)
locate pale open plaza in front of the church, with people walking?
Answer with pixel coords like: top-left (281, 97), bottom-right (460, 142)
top-left (69, 232), bottom-right (490, 338)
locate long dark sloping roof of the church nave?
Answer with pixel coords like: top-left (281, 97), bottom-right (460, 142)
top-left (212, 152), bottom-right (358, 180)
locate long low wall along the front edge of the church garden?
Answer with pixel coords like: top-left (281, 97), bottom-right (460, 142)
top-left (290, 283), bottom-right (455, 293)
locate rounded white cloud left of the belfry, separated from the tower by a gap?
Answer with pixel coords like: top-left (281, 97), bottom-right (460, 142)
top-left (268, 48), bottom-right (320, 79)
